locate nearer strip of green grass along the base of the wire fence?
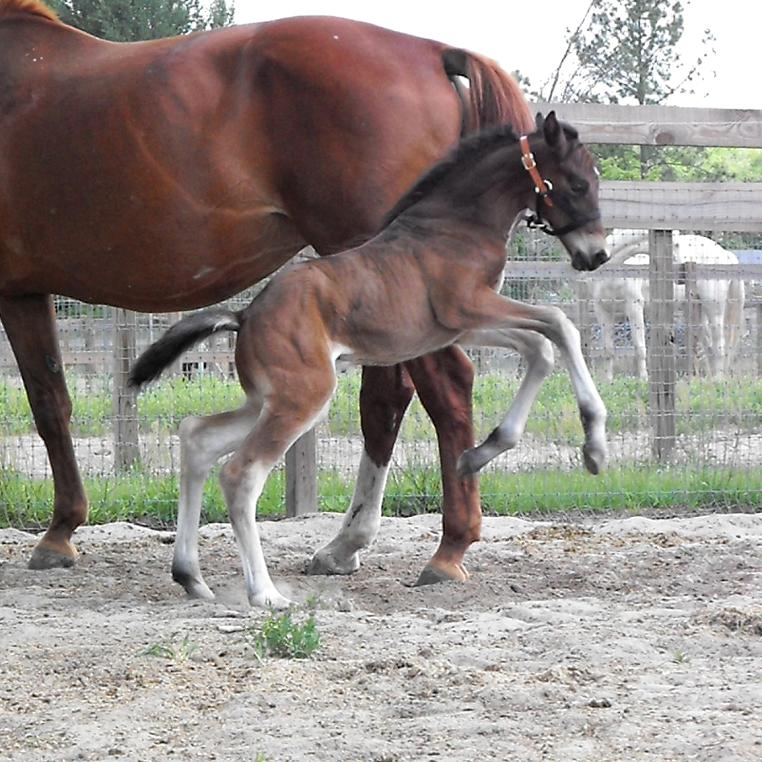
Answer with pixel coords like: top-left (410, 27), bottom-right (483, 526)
top-left (0, 466), bottom-right (762, 528)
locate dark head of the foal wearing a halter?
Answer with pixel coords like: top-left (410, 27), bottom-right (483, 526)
top-left (520, 111), bottom-right (610, 270)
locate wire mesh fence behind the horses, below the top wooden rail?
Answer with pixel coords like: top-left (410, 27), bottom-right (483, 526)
top-left (0, 107), bottom-right (762, 526)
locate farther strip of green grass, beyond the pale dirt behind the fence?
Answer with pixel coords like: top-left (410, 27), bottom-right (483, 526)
top-left (0, 372), bottom-right (762, 441)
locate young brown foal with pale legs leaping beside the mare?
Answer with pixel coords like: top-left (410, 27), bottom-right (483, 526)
top-left (130, 112), bottom-right (608, 607)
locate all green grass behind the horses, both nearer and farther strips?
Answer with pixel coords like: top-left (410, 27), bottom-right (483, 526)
top-left (0, 373), bottom-right (762, 528)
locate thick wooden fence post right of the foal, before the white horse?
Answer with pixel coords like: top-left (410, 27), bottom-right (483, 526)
top-left (648, 230), bottom-right (677, 460)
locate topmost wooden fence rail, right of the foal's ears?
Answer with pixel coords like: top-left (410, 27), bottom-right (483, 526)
top-left (535, 103), bottom-right (762, 148)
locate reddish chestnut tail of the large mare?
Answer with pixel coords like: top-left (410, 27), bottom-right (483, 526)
top-left (442, 48), bottom-right (535, 134)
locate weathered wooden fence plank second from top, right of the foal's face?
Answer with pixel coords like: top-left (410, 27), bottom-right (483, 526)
top-left (600, 180), bottom-right (762, 232)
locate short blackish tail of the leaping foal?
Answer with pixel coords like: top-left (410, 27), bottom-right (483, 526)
top-left (127, 307), bottom-right (241, 388)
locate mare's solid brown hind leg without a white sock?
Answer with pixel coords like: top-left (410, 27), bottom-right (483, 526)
top-left (406, 346), bottom-right (482, 585)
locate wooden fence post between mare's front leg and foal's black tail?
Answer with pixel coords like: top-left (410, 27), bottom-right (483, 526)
top-left (112, 307), bottom-right (140, 473)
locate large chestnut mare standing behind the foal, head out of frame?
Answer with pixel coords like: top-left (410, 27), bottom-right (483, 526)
top-left (0, 0), bottom-right (533, 579)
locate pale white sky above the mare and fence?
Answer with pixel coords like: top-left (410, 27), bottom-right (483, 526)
top-left (235, 0), bottom-right (762, 109)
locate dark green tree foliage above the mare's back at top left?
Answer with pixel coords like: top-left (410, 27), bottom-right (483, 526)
top-left (49, 0), bottom-right (235, 42)
